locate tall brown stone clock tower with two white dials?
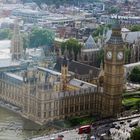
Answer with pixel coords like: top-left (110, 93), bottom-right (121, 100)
top-left (101, 21), bottom-right (125, 117)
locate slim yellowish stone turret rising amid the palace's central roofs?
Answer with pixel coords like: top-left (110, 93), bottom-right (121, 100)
top-left (61, 56), bottom-right (68, 91)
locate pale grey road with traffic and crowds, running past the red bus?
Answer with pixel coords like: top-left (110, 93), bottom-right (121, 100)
top-left (32, 114), bottom-right (140, 140)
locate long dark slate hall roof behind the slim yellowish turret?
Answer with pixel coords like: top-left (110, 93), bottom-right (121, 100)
top-left (54, 57), bottom-right (100, 77)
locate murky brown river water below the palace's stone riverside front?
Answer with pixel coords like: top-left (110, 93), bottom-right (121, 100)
top-left (0, 107), bottom-right (41, 140)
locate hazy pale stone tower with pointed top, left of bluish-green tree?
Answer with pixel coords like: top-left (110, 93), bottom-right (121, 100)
top-left (11, 19), bottom-right (23, 60)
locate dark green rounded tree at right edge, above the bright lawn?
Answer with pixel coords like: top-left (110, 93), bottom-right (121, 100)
top-left (129, 67), bottom-right (140, 83)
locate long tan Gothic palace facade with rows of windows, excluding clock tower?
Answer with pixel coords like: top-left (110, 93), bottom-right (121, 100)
top-left (0, 68), bottom-right (101, 124)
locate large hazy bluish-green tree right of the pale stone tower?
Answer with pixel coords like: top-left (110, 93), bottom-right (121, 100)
top-left (29, 27), bottom-right (55, 55)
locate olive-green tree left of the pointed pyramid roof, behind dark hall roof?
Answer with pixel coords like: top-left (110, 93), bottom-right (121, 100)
top-left (61, 38), bottom-right (82, 60)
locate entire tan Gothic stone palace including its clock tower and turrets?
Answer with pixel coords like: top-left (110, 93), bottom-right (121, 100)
top-left (0, 22), bottom-right (125, 124)
